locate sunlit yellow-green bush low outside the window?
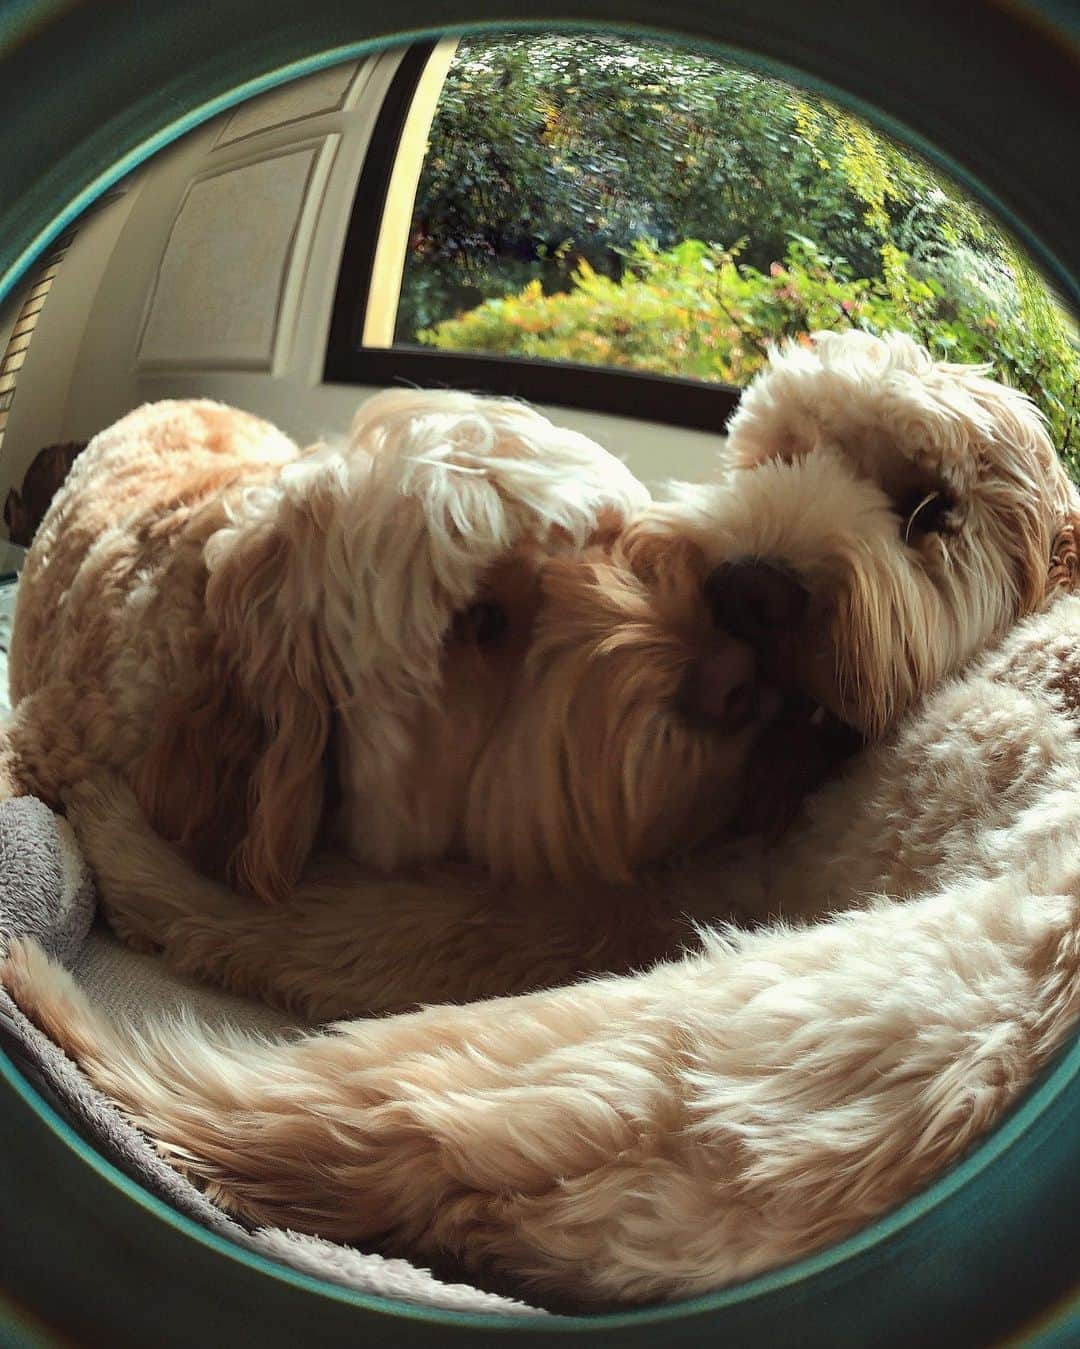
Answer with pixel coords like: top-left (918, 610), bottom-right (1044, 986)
top-left (419, 235), bottom-right (1080, 475)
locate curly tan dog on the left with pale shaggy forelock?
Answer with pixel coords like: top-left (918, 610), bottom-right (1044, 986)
top-left (9, 391), bottom-right (825, 1014)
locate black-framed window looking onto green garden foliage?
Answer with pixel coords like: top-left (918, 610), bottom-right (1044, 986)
top-left (328, 34), bottom-right (1080, 464)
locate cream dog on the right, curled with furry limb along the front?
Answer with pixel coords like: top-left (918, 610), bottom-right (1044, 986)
top-left (3, 336), bottom-right (1080, 1303)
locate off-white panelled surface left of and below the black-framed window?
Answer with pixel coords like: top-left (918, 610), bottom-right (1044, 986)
top-left (0, 53), bottom-right (717, 515)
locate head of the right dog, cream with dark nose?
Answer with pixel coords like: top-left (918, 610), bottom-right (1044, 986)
top-left (660, 332), bottom-right (1080, 737)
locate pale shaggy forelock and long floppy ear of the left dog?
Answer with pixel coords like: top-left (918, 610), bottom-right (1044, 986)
top-left (155, 390), bottom-right (649, 898)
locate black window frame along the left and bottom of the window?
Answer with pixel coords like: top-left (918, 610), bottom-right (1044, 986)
top-left (322, 42), bottom-right (742, 433)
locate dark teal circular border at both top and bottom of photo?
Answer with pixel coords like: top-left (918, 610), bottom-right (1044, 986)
top-left (0, 0), bottom-right (1080, 1349)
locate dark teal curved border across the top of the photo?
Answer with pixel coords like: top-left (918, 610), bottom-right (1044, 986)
top-left (0, 0), bottom-right (1080, 306)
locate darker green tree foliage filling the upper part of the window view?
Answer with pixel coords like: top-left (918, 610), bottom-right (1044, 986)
top-left (398, 35), bottom-right (984, 341)
